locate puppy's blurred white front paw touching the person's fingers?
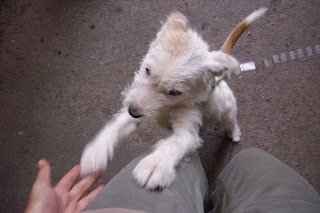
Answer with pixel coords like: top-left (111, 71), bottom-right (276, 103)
top-left (80, 142), bottom-right (108, 176)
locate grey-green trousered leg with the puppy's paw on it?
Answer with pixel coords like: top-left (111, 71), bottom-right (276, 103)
top-left (85, 154), bottom-right (208, 213)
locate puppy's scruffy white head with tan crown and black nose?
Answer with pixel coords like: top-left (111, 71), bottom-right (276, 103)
top-left (124, 12), bottom-right (239, 118)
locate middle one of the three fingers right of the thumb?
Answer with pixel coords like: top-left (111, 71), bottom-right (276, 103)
top-left (70, 174), bottom-right (100, 201)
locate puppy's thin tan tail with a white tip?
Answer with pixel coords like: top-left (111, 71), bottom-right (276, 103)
top-left (220, 7), bottom-right (268, 54)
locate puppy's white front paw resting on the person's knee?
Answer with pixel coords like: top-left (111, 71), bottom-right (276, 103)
top-left (133, 154), bottom-right (175, 190)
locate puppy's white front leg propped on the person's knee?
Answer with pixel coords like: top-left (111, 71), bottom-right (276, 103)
top-left (133, 109), bottom-right (202, 190)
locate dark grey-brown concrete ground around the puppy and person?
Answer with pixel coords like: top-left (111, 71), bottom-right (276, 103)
top-left (0, 0), bottom-right (320, 212)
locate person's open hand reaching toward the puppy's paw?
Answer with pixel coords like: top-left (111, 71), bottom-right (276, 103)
top-left (25, 159), bottom-right (103, 213)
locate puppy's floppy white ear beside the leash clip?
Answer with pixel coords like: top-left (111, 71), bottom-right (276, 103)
top-left (206, 51), bottom-right (240, 76)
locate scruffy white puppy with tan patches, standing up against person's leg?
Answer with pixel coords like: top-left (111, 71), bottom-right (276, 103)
top-left (81, 8), bottom-right (266, 189)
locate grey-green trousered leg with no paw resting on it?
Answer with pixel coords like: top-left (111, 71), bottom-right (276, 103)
top-left (214, 148), bottom-right (320, 213)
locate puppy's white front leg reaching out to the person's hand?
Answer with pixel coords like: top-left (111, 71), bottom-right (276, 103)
top-left (80, 108), bottom-right (139, 176)
